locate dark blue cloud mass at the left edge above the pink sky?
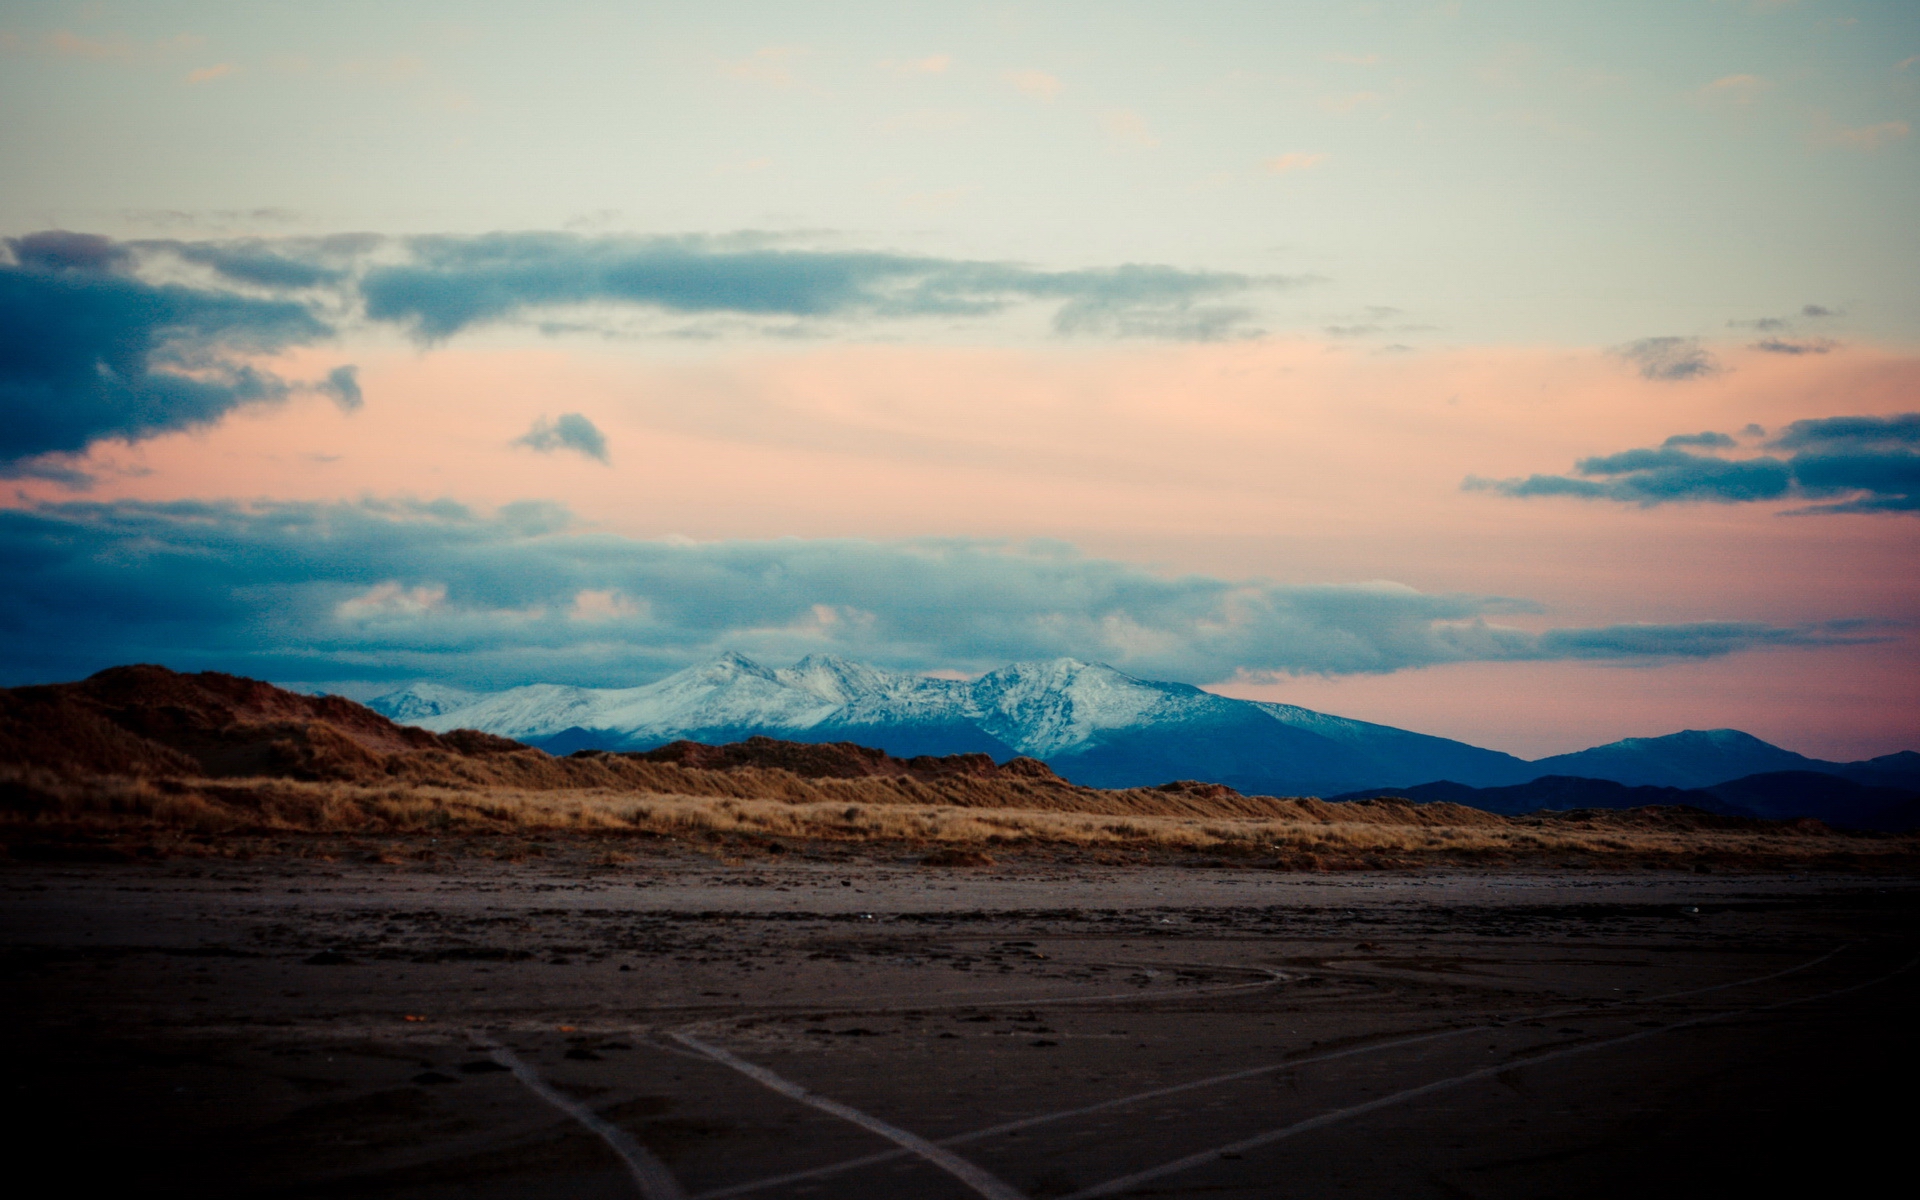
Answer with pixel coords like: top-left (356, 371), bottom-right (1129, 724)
top-left (0, 230), bottom-right (330, 470)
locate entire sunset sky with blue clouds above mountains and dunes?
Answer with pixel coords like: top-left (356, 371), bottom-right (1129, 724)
top-left (0, 0), bottom-right (1920, 758)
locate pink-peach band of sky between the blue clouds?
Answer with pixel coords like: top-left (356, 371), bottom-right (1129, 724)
top-left (25, 340), bottom-right (1920, 758)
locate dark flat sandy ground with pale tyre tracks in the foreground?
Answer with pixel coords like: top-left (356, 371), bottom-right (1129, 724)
top-left (0, 862), bottom-right (1920, 1200)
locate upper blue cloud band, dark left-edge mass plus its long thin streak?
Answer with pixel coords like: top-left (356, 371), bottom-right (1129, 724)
top-left (0, 226), bottom-right (1306, 466)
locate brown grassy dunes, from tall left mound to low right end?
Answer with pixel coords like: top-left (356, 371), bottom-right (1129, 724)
top-left (0, 666), bottom-right (1920, 868)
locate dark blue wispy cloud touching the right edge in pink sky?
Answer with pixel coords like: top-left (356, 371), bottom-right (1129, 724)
top-left (1465, 413), bottom-right (1920, 516)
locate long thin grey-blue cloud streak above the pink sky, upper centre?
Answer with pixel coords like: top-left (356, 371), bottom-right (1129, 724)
top-left (361, 232), bottom-right (1292, 342)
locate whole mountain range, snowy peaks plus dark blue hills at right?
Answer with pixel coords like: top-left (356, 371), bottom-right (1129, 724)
top-left (367, 653), bottom-right (1920, 797)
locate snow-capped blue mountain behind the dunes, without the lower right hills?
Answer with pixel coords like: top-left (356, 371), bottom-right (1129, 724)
top-left (376, 653), bottom-right (1519, 791)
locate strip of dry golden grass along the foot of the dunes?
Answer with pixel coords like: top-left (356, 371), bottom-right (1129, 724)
top-left (0, 772), bottom-right (1920, 870)
